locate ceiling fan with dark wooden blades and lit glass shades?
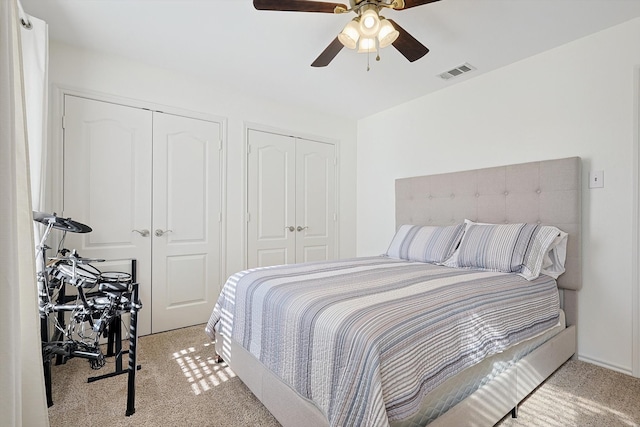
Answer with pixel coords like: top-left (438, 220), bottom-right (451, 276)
top-left (253, 0), bottom-right (439, 67)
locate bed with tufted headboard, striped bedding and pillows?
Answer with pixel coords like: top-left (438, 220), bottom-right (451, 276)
top-left (206, 157), bottom-right (581, 427)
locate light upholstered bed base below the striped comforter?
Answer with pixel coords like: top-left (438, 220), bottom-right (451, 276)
top-left (216, 326), bottom-right (576, 427)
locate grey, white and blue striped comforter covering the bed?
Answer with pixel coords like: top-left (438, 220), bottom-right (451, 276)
top-left (206, 257), bottom-right (559, 426)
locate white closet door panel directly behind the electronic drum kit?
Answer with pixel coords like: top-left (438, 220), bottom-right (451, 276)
top-left (62, 95), bottom-right (152, 335)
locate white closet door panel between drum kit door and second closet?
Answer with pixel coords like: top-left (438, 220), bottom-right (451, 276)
top-left (150, 113), bottom-right (222, 333)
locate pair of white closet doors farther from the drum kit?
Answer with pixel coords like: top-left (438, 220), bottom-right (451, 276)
top-left (247, 129), bottom-right (337, 268)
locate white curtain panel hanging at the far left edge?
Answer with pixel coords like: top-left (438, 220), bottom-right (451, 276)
top-left (0, 0), bottom-right (49, 427)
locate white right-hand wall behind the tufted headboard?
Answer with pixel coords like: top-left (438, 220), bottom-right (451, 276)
top-left (357, 19), bottom-right (640, 373)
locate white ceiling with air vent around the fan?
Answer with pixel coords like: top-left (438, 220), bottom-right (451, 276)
top-left (21, 0), bottom-right (640, 119)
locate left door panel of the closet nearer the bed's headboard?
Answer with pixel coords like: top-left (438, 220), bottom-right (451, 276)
top-left (247, 129), bottom-right (297, 268)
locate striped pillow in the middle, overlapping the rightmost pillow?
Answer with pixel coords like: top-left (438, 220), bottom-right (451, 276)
top-left (451, 222), bottom-right (539, 273)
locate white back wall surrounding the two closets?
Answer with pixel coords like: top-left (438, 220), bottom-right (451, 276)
top-left (48, 42), bottom-right (356, 284)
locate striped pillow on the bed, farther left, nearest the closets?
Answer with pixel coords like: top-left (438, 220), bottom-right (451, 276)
top-left (386, 224), bottom-right (464, 264)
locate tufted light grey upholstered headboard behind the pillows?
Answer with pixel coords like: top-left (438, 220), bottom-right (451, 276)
top-left (396, 157), bottom-right (582, 321)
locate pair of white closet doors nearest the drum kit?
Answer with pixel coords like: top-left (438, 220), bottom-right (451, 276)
top-left (63, 95), bottom-right (221, 335)
